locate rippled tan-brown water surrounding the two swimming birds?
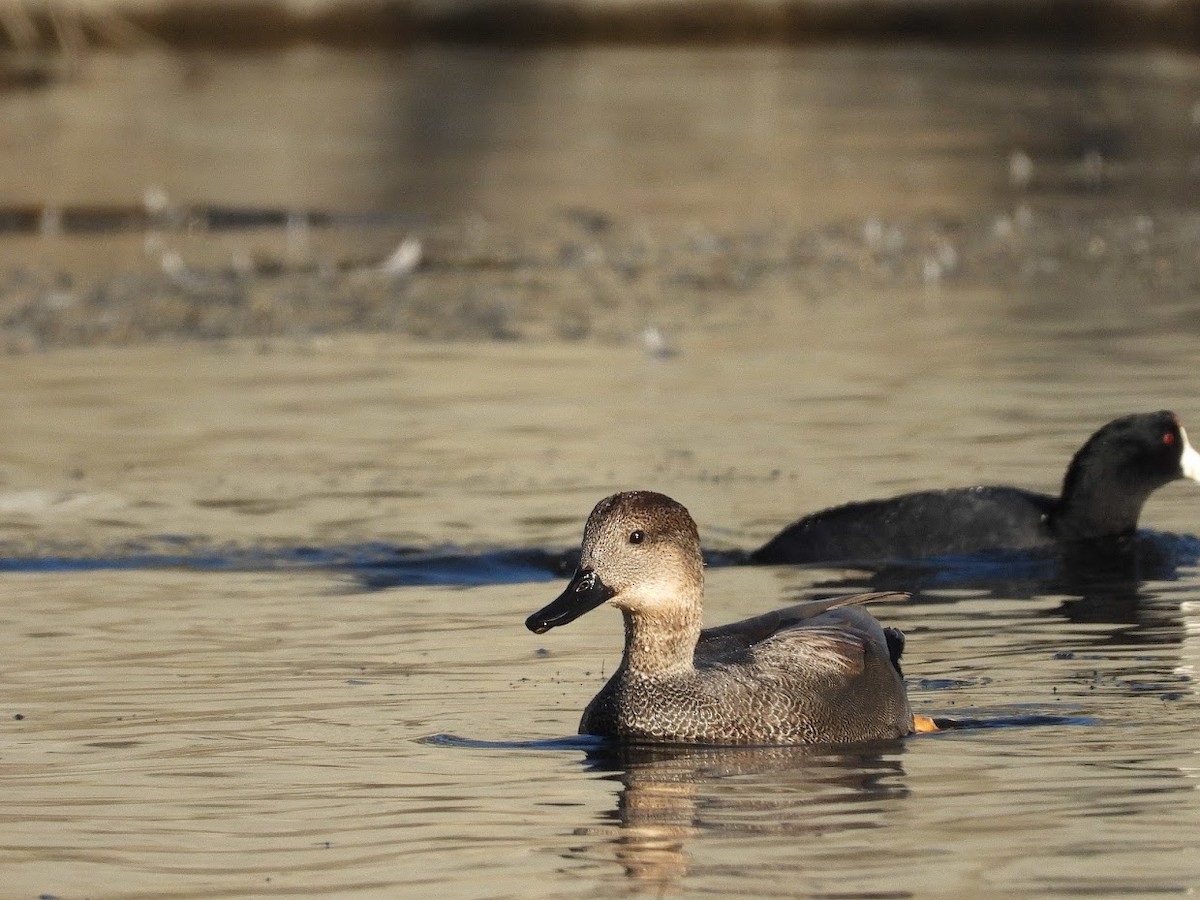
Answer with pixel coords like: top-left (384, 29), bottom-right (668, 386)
top-left (0, 44), bottom-right (1200, 898)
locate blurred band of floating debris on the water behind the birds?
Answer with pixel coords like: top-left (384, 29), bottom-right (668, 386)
top-left (0, 206), bottom-right (1200, 354)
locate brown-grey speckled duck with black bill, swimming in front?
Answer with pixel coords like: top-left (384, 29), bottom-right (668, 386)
top-left (526, 491), bottom-right (934, 744)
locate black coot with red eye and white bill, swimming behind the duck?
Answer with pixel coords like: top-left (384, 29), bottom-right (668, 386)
top-left (750, 410), bottom-right (1200, 564)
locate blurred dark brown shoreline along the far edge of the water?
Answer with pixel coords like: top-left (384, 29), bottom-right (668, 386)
top-left (7, 0), bottom-right (1200, 50)
